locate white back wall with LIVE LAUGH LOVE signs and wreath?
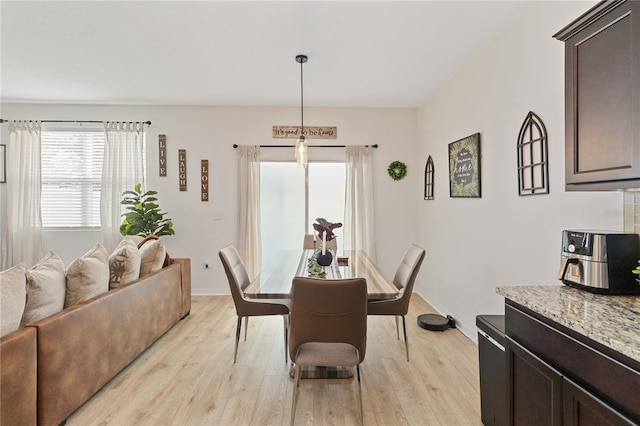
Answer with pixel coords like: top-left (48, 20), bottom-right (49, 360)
top-left (0, 104), bottom-right (422, 294)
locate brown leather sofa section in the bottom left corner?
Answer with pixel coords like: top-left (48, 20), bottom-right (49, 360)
top-left (0, 327), bottom-right (37, 425)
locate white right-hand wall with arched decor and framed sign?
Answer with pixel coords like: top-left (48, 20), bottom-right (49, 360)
top-left (416, 2), bottom-right (623, 340)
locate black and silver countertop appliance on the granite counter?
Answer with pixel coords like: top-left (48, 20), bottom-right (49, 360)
top-left (558, 230), bottom-right (640, 294)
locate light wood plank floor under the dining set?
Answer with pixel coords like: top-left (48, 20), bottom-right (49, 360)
top-left (67, 295), bottom-right (482, 426)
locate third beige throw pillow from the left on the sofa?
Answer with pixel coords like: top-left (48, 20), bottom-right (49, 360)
top-left (64, 244), bottom-right (109, 308)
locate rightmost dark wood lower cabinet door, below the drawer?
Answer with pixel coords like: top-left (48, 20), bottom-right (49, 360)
top-left (562, 377), bottom-right (634, 426)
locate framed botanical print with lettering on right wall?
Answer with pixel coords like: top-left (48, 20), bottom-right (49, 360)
top-left (449, 133), bottom-right (481, 198)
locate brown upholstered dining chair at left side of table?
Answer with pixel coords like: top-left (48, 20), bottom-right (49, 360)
top-left (219, 245), bottom-right (291, 364)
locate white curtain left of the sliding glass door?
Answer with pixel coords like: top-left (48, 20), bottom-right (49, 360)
top-left (238, 146), bottom-right (262, 279)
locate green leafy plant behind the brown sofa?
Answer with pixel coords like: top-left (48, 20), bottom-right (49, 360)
top-left (120, 183), bottom-right (175, 237)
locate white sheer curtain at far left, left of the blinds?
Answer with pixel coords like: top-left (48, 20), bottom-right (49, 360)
top-left (3, 121), bottom-right (42, 269)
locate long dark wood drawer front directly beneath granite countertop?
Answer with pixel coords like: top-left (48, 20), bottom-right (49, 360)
top-left (505, 304), bottom-right (640, 422)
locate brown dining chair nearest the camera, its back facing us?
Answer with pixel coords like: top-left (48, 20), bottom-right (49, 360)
top-left (289, 277), bottom-right (367, 424)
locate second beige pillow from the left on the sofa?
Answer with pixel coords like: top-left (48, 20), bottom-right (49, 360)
top-left (22, 251), bottom-right (66, 326)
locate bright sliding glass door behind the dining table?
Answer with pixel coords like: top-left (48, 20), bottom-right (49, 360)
top-left (260, 161), bottom-right (345, 265)
